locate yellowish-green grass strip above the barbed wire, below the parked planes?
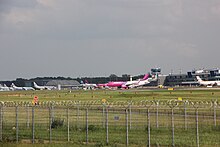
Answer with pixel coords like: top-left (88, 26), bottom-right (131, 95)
top-left (0, 87), bottom-right (220, 102)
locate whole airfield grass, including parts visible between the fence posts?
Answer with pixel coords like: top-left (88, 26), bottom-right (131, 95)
top-left (0, 89), bottom-right (220, 147)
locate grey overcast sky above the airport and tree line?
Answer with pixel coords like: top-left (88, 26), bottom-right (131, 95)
top-left (0, 0), bottom-right (220, 80)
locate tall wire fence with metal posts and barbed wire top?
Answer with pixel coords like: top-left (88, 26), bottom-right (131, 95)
top-left (0, 100), bottom-right (220, 146)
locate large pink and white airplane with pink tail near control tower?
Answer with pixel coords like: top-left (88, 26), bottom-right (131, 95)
top-left (97, 74), bottom-right (149, 89)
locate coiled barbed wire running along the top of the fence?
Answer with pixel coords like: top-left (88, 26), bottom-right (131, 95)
top-left (0, 99), bottom-right (220, 109)
